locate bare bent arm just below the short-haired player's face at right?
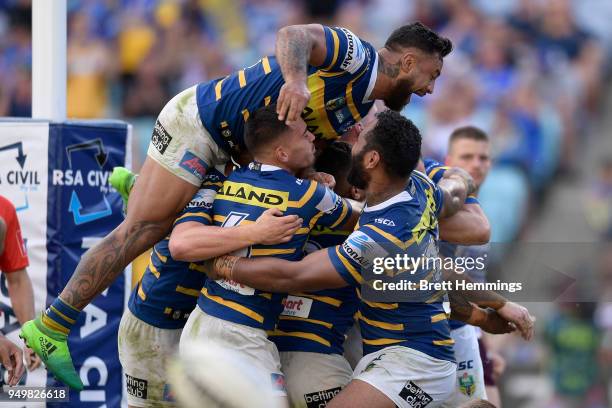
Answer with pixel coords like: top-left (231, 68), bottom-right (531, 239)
top-left (440, 204), bottom-right (491, 245)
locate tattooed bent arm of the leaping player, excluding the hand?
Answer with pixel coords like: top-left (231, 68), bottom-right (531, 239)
top-left (276, 24), bottom-right (325, 82)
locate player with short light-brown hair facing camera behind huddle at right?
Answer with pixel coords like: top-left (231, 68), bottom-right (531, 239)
top-left (425, 126), bottom-right (501, 407)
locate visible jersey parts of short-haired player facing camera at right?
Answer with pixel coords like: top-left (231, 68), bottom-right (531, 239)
top-left (424, 159), bottom-right (489, 330)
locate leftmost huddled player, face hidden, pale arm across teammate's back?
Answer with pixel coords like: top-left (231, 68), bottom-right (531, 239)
top-left (110, 164), bottom-right (301, 407)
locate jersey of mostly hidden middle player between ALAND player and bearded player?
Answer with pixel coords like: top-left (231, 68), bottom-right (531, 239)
top-left (270, 226), bottom-right (359, 354)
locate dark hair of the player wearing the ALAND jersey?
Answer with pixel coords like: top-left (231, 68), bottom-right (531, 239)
top-left (244, 104), bottom-right (289, 154)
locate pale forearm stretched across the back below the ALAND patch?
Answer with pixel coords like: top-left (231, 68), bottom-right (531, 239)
top-left (168, 225), bottom-right (257, 262)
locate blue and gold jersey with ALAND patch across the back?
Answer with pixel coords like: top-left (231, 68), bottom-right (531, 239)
top-left (198, 163), bottom-right (351, 330)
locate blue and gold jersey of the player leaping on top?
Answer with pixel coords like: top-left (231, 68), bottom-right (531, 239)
top-left (196, 27), bottom-right (378, 153)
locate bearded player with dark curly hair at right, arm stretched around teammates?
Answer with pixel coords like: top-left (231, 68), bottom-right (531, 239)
top-left (203, 111), bottom-right (528, 408)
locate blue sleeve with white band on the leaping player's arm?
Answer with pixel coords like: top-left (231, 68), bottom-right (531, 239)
top-left (319, 26), bottom-right (371, 74)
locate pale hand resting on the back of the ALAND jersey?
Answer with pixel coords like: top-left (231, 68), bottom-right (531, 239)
top-left (254, 208), bottom-right (304, 245)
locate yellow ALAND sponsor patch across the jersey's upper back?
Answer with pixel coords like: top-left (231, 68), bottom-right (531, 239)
top-left (217, 181), bottom-right (289, 211)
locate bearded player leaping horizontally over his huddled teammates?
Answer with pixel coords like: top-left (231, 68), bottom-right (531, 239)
top-left (21, 23), bottom-right (452, 388)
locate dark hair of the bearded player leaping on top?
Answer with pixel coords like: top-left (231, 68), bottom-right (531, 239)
top-left (385, 22), bottom-right (453, 58)
